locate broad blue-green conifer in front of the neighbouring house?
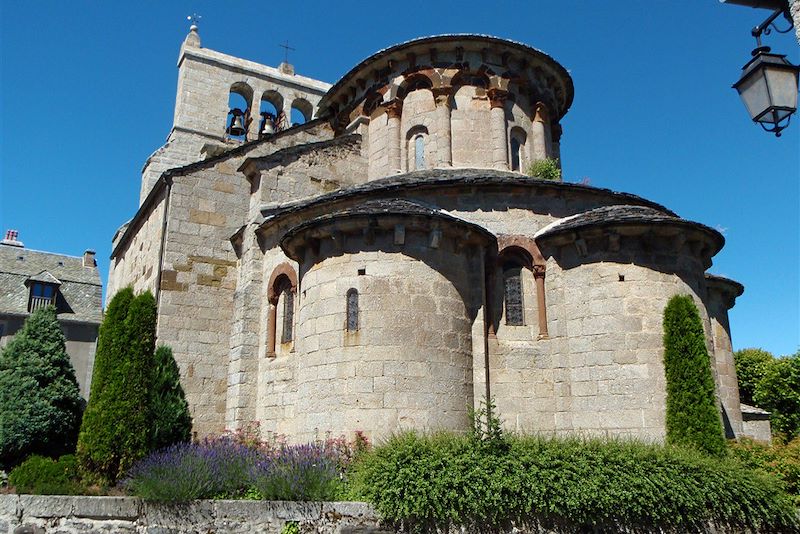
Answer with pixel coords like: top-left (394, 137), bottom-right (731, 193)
top-left (0, 306), bottom-right (83, 467)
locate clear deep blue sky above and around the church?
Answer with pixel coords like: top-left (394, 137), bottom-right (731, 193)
top-left (0, 4), bottom-right (800, 354)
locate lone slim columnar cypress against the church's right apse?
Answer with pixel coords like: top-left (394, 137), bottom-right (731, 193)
top-left (664, 295), bottom-right (725, 455)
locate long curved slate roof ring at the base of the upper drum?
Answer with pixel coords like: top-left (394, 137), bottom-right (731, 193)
top-left (261, 169), bottom-right (677, 224)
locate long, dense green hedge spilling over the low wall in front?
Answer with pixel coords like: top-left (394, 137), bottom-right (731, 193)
top-left (350, 433), bottom-right (800, 532)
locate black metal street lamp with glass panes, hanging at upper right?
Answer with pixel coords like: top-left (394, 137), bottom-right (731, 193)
top-left (723, 0), bottom-right (800, 137)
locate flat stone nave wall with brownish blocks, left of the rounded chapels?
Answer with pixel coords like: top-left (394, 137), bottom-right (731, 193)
top-left (108, 124), bottom-right (330, 436)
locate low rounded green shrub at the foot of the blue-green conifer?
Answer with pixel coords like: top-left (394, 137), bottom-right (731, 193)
top-left (8, 454), bottom-right (86, 495)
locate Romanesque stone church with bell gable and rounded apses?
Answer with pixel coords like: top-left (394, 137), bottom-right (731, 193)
top-left (108, 26), bottom-right (743, 441)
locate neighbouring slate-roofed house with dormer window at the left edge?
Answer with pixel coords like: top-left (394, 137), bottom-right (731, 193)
top-left (0, 230), bottom-right (102, 399)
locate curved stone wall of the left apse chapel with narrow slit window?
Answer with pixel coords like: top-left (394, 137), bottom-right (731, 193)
top-left (259, 232), bottom-right (480, 441)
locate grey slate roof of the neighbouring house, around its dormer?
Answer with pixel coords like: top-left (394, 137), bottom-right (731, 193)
top-left (0, 245), bottom-right (103, 324)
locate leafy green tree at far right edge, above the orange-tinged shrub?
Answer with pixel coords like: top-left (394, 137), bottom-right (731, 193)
top-left (754, 352), bottom-right (800, 441)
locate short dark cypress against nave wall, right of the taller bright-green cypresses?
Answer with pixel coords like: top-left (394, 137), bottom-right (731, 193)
top-left (150, 345), bottom-right (192, 449)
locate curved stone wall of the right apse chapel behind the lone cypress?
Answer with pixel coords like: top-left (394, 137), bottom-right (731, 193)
top-left (528, 236), bottom-right (708, 441)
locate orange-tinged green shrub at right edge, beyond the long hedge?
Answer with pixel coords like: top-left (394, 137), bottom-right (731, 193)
top-left (730, 437), bottom-right (800, 507)
